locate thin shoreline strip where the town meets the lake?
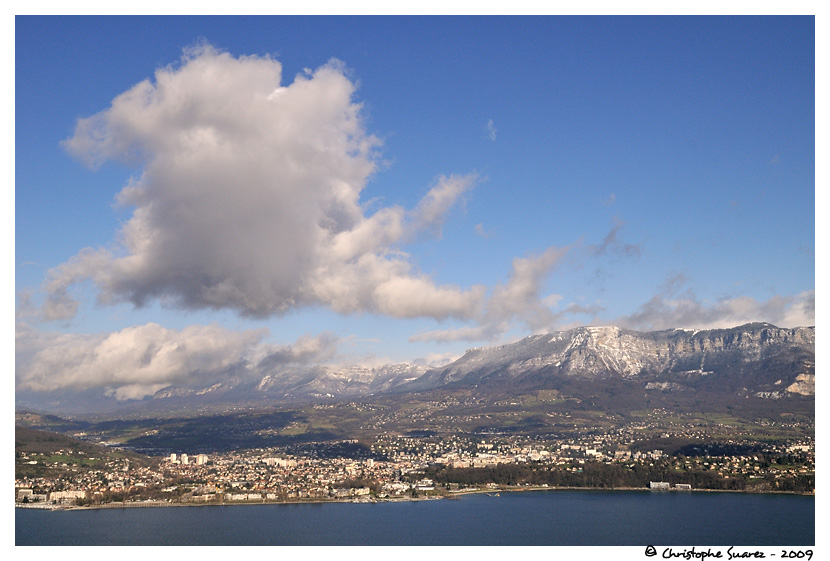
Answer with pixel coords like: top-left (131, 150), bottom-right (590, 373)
top-left (15, 486), bottom-right (815, 511)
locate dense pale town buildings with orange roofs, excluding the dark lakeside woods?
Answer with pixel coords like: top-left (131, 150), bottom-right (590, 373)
top-left (15, 428), bottom-right (815, 508)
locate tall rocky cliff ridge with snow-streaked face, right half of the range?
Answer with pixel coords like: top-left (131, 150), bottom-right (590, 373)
top-left (403, 323), bottom-right (815, 397)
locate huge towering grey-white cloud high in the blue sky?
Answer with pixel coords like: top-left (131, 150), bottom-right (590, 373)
top-left (42, 45), bottom-right (485, 320)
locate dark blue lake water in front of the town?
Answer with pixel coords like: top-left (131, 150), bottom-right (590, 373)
top-left (15, 491), bottom-right (815, 546)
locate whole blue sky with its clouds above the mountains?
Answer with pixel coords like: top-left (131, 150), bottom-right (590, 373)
top-left (14, 16), bottom-right (816, 398)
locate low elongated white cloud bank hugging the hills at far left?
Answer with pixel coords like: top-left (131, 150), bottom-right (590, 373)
top-left (15, 323), bottom-right (338, 400)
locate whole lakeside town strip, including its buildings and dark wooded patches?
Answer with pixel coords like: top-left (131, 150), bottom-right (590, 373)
top-left (15, 428), bottom-right (815, 508)
